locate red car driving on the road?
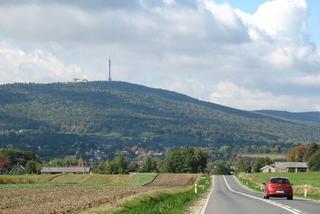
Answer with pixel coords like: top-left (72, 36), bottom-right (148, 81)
top-left (264, 177), bottom-right (293, 200)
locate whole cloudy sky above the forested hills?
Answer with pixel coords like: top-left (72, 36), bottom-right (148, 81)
top-left (0, 0), bottom-right (320, 112)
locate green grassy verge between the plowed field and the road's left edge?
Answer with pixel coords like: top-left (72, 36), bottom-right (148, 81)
top-left (87, 177), bottom-right (211, 214)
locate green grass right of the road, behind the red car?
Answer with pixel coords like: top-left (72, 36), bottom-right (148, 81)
top-left (237, 172), bottom-right (320, 200)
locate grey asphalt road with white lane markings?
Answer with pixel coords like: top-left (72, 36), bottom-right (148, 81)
top-left (204, 176), bottom-right (320, 214)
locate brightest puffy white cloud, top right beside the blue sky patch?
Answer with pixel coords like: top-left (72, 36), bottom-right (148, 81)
top-left (236, 0), bottom-right (319, 69)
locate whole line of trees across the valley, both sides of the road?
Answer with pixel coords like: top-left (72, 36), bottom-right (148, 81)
top-left (0, 144), bottom-right (320, 174)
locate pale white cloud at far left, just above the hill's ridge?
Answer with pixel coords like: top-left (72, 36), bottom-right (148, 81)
top-left (0, 43), bottom-right (90, 83)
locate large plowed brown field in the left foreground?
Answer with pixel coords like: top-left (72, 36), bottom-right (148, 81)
top-left (0, 186), bottom-right (152, 214)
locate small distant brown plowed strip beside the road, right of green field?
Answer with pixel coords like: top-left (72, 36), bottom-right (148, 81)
top-left (147, 173), bottom-right (200, 187)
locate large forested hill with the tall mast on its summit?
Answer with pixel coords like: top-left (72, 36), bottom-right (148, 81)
top-left (0, 82), bottom-right (320, 160)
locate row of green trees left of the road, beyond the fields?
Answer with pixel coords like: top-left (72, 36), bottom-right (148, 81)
top-left (0, 147), bottom-right (208, 174)
